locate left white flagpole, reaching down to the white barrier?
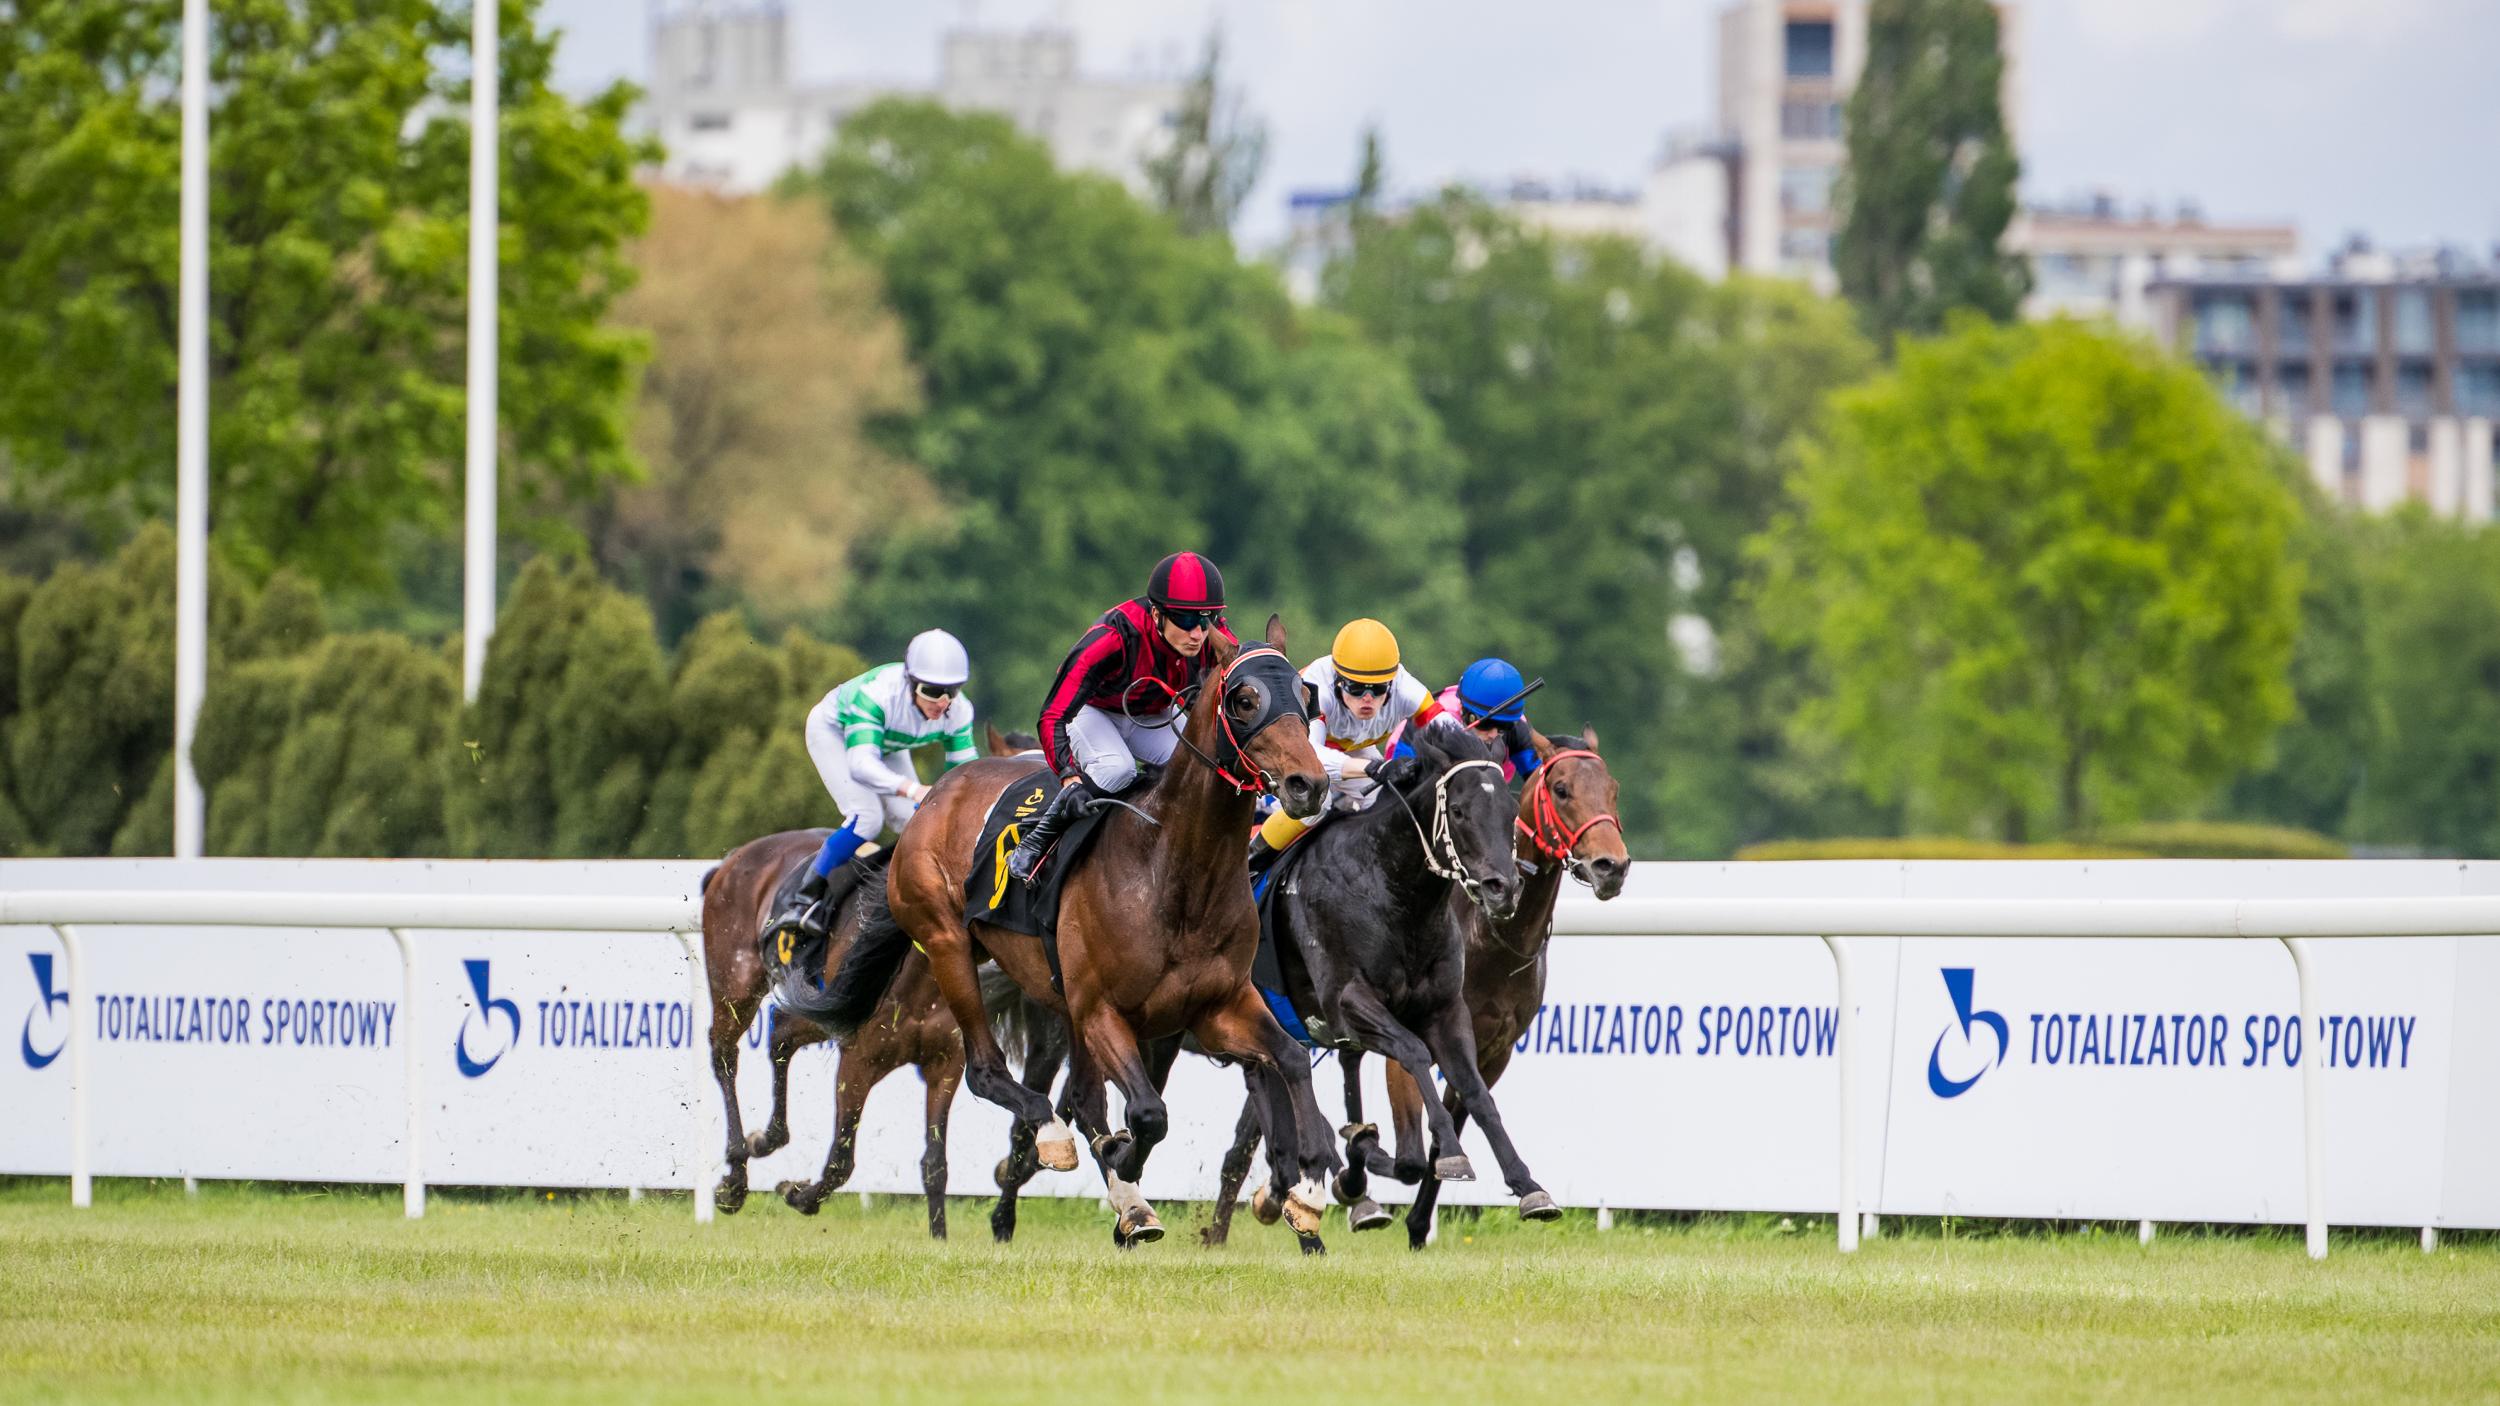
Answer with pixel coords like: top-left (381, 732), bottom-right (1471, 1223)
top-left (173, 0), bottom-right (208, 858)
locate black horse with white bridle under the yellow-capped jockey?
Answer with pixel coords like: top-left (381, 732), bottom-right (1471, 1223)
top-left (1205, 728), bottom-right (1563, 1253)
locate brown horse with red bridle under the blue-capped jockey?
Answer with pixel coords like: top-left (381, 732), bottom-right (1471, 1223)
top-left (1345, 728), bottom-right (1633, 1248)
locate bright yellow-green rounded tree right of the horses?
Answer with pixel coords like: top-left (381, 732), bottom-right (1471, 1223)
top-left (1763, 320), bottom-right (2300, 841)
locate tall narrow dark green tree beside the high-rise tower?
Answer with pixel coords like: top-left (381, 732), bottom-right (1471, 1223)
top-left (1833, 0), bottom-right (2030, 348)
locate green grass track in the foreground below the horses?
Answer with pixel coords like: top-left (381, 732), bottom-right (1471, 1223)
top-left (0, 1178), bottom-right (2500, 1406)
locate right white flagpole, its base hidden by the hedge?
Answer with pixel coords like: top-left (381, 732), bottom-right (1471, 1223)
top-left (460, 0), bottom-right (500, 698)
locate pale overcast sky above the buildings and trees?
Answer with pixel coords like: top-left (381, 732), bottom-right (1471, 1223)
top-left (540, 0), bottom-right (2500, 260)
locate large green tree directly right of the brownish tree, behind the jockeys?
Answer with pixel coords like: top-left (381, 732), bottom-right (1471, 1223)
top-left (818, 103), bottom-right (1458, 721)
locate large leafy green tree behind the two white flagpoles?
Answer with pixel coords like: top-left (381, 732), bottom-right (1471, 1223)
top-left (0, 0), bottom-right (650, 588)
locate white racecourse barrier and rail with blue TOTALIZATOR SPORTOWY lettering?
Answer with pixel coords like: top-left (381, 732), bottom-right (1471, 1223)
top-left (0, 861), bottom-right (2500, 1253)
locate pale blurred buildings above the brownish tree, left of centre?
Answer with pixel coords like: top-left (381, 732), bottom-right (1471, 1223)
top-left (645, 0), bottom-right (1183, 190)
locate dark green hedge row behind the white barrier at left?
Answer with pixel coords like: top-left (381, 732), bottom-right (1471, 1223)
top-left (0, 528), bottom-right (863, 858)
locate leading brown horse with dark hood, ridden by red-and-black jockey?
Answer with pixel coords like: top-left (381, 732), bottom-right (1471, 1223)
top-left (838, 618), bottom-right (1343, 1246)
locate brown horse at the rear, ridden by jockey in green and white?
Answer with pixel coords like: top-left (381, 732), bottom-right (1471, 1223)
top-left (703, 728), bottom-right (1075, 1238)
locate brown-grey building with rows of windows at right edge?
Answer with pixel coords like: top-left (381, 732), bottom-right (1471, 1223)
top-left (2150, 248), bottom-right (2500, 523)
